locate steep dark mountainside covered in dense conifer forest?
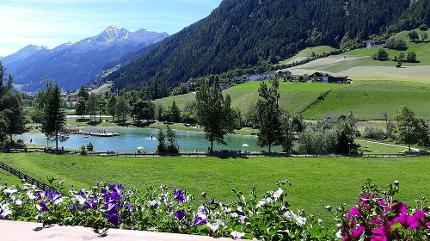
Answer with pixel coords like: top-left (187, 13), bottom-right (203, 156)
top-left (104, 0), bottom-right (430, 89)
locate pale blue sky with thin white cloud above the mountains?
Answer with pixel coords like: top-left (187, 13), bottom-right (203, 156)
top-left (0, 0), bottom-right (221, 56)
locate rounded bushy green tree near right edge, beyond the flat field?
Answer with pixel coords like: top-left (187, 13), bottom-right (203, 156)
top-left (394, 106), bottom-right (418, 152)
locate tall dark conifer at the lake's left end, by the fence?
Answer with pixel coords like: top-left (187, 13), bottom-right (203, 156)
top-left (42, 83), bottom-right (66, 150)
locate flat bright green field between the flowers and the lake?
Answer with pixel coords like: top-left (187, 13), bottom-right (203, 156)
top-left (0, 154), bottom-right (430, 225)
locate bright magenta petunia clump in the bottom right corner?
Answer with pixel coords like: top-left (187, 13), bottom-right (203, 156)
top-left (337, 181), bottom-right (430, 241)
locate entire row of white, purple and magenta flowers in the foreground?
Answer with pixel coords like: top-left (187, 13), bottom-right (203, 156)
top-left (0, 182), bottom-right (430, 241)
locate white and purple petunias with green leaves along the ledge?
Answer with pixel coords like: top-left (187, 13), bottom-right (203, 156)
top-left (0, 182), bottom-right (332, 240)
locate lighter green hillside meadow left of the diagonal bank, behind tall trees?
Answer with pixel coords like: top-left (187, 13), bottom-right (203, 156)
top-left (155, 81), bottom-right (347, 113)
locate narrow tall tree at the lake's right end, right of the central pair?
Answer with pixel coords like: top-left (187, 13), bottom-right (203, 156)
top-left (257, 80), bottom-right (283, 153)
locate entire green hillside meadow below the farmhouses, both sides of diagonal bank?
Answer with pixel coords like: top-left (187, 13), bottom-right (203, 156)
top-left (155, 80), bottom-right (430, 120)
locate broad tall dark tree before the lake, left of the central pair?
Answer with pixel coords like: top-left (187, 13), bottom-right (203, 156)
top-left (196, 79), bottom-right (234, 152)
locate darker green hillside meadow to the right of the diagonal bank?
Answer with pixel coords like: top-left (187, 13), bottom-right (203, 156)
top-left (303, 81), bottom-right (430, 120)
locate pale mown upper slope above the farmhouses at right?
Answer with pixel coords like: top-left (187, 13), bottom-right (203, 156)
top-left (291, 30), bottom-right (430, 83)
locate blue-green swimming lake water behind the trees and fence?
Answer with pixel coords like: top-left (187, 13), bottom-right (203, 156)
top-left (16, 127), bottom-right (276, 152)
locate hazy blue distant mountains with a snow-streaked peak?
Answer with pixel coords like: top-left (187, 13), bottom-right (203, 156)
top-left (0, 26), bottom-right (168, 92)
